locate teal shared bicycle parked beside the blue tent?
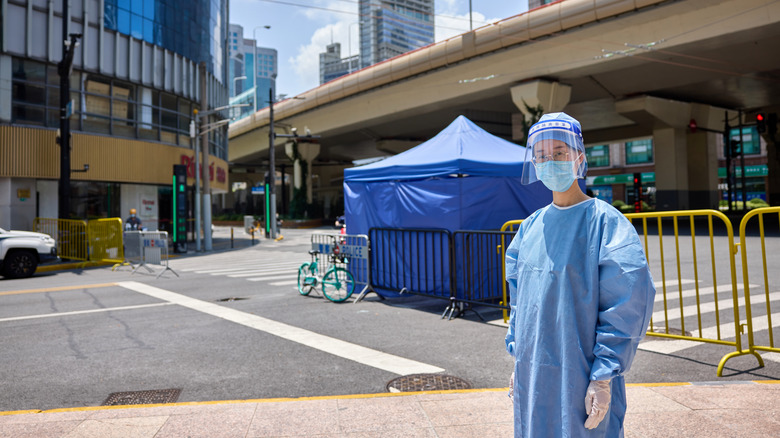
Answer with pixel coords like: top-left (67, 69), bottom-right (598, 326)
top-left (298, 237), bottom-right (355, 303)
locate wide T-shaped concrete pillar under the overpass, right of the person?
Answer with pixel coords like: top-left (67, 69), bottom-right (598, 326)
top-left (615, 96), bottom-right (725, 210)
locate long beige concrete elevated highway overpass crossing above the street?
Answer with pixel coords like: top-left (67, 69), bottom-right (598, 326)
top-left (229, 0), bottom-right (780, 214)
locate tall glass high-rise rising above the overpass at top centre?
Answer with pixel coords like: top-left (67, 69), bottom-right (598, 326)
top-left (359, 0), bottom-right (434, 67)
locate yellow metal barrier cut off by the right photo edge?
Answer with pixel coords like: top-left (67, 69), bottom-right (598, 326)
top-left (732, 207), bottom-right (780, 366)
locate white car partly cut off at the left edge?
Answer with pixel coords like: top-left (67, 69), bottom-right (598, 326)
top-left (0, 228), bottom-right (59, 278)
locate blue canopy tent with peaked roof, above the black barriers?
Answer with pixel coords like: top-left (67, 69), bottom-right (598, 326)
top-left (344, 116), bottom-right (552, 234)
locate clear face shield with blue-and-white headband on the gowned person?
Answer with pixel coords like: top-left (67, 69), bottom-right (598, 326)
top-left (521, 113), bottom-right (588, 192)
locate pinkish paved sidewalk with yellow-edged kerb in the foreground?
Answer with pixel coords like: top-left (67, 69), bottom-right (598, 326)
top-left (0, 381), bottom-right (780, 438)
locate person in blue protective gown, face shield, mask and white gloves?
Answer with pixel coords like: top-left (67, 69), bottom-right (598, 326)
top-left (506, 113), bottom-right (655, 437)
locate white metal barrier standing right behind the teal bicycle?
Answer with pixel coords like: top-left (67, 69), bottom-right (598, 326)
top-left (311, 233), bottom-right (374, 302)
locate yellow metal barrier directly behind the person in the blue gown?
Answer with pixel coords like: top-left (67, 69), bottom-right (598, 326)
top-left (499, 209), bottom-right (760, 376)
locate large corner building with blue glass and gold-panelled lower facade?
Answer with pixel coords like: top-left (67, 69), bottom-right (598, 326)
top-left (0, 0), bottom-right (228, 230)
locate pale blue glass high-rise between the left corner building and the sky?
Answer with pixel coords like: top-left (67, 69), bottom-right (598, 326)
top-left (228, 24), bottom-right (279, 119)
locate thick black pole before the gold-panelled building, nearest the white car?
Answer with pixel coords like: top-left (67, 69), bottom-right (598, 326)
top-left (57, 0), bottom-right (81, 219)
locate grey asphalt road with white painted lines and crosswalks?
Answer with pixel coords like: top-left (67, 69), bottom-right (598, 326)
top-left (0, 228), bottom-right (780, 411)
